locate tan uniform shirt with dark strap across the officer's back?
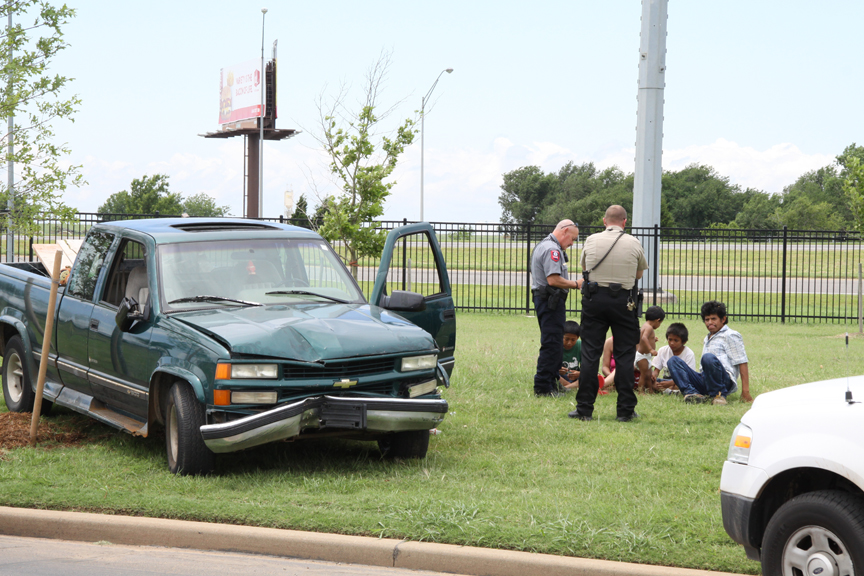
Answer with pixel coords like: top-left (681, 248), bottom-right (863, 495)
top-left (581, 226), bottom-right (648, 290)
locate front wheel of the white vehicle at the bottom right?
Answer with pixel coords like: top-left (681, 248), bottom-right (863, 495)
top-left (762, 490), bottom-right (864, 576)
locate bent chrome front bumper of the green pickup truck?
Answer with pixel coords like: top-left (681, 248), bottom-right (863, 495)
top-left (201, 396), bottom-right (448, 453)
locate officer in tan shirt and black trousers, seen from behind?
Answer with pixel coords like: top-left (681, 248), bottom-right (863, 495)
top-left (570, 205), bottom-right (648, 422)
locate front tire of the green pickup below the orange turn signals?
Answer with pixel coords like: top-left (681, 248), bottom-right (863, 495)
top-left (165, 382), bottom-right (214, 476)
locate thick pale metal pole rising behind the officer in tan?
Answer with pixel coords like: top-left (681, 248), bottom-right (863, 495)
top-left (631, 0), bottom-right (668, 291)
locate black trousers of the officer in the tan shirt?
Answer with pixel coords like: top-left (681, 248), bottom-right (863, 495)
top-left (576, 288), bottom-right (639, 417)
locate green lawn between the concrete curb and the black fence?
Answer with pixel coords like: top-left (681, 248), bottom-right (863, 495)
top-left (0, 313), bottom-right (864, 573)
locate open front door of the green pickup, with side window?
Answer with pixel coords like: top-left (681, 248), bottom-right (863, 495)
top-left (369, 222), bottom-right (456, 375)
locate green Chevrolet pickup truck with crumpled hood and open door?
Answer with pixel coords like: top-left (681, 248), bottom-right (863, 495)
top-left (0, 218), bottom-right (456, 474)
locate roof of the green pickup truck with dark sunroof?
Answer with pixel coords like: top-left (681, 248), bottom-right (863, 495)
top-left (96, 218), bottom-right (320, 244)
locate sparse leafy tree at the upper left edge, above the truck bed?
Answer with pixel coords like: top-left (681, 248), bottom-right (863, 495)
top-left (0, 0), bottom-right (83, 235)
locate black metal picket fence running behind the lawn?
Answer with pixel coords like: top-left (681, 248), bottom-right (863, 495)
top-left (2, 213), bottom-right (864, 323)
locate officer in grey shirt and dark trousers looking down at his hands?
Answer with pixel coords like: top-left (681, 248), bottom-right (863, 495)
top-left (531, 220), bottom-right (582, 396)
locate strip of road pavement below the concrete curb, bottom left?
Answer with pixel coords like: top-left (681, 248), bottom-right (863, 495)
top-left (0, 536), bottom-right (466, 576)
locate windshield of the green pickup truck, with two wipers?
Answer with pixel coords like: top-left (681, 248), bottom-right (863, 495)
top-left (157, 239), bottom-right (365, 311)
